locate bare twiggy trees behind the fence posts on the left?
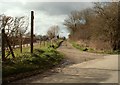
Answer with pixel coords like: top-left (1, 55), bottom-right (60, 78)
top-left (0, 14), bottom-right (28, 55)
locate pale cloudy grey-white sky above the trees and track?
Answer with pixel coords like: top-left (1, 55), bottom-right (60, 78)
top-left (0, 0), bottom-right (118, 36)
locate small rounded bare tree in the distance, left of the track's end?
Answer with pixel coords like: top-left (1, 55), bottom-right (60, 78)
top-left (47, 25), bottom-right (60, 39)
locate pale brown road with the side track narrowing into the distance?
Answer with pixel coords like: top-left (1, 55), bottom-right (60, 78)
top-left (14, 43), bottom-right (119, 83)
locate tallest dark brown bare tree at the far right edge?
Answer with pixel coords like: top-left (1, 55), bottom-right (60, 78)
top-left (95, 2), bottom-right (120, 50)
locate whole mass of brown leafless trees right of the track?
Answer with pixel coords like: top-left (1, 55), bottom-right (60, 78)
top-left (64, 2), bottom-right (120, 50)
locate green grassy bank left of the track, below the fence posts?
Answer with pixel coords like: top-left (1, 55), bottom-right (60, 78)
top-left (2, 40), bottom-right (63, 80)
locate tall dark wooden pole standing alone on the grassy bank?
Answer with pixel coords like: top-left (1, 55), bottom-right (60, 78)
top-left (31, 11), bottom-right (34, 53)
